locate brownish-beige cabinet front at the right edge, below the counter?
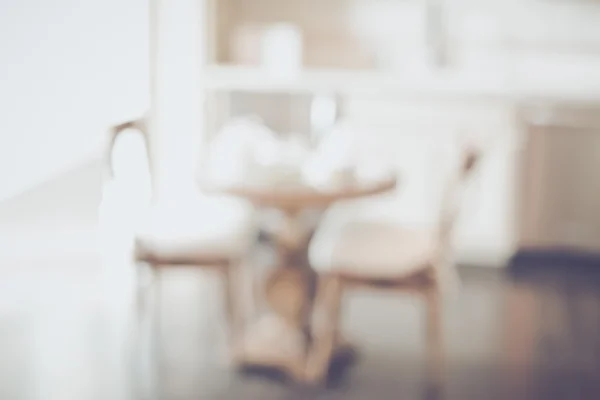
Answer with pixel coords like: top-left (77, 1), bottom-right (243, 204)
top-left (519, 106), bottom-right (600, 252)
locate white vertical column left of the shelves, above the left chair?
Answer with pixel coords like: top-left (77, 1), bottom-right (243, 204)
top-left (151, 0), bottom-right (206, 200)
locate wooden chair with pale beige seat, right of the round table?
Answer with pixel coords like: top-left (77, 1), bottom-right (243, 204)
top-left (306, 141), bottom-right (479, 387)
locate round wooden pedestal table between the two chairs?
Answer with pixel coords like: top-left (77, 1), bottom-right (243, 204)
top-left (210, 175), bottom-right (396, 380)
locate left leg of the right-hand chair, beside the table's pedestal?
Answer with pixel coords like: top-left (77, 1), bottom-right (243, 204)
top-left (305, 277), bottom-right (343, 383)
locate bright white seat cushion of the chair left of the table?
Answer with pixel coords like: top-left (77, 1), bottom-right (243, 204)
top-left (136, 196), bottom-right (257, 264)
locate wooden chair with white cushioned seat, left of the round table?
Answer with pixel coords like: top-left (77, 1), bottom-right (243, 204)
top-left (106, 119), bottom-right (256, 348)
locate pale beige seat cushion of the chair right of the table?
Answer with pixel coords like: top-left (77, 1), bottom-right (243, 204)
top-left (309, 221), bottom-right (437, 280)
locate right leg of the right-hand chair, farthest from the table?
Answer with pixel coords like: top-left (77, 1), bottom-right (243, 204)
top-left (426, 288), bottom-right (444, 388)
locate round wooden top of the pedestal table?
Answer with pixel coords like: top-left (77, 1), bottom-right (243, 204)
top-left (207, 175), bottom-right (396, 209)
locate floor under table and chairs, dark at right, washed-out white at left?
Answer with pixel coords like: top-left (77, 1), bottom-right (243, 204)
top-left (0, 164), bottom-right (600, 400)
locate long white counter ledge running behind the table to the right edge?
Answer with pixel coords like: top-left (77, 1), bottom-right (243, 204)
top-left (204, 63), bottom-right (600, 102)
